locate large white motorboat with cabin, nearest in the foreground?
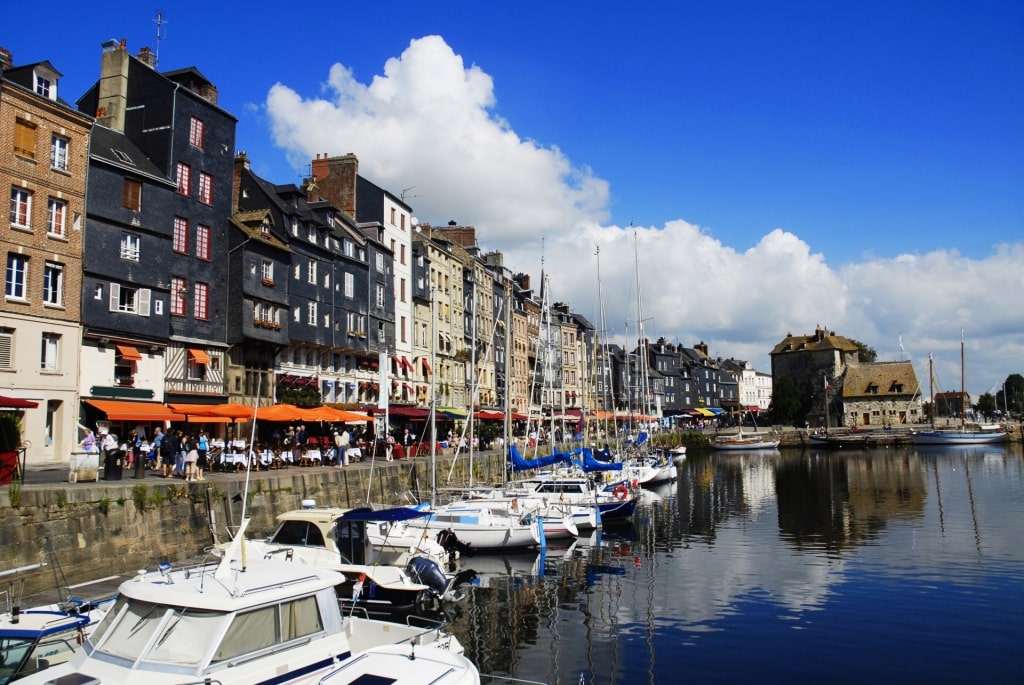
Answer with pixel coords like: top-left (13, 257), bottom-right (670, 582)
top-left (22, 525), bottom-right (472, 685)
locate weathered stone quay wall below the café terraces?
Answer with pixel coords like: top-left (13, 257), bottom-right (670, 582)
top-left (0, 453), bottom-right (504, 597)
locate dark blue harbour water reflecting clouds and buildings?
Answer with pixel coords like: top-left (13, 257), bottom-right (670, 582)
top-left (452, 444), bottom-right (1024, 685)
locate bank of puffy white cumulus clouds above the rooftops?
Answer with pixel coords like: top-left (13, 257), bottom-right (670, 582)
top-left (266, 36), bottom-right (1024, 394)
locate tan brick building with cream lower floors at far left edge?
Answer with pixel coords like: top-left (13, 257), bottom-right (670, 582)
top-left (0, 48), bottom-right (92, 464)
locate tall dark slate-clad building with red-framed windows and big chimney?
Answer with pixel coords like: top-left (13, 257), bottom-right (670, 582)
top-left (78, 41), bottom-right (237, 402)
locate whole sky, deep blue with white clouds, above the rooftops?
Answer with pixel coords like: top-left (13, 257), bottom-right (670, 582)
top-left (0, 1), bottom-right (1024, 394)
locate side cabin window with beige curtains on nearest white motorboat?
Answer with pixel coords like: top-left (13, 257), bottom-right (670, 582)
top-left (212, 597), bottom-right (324, 663)
